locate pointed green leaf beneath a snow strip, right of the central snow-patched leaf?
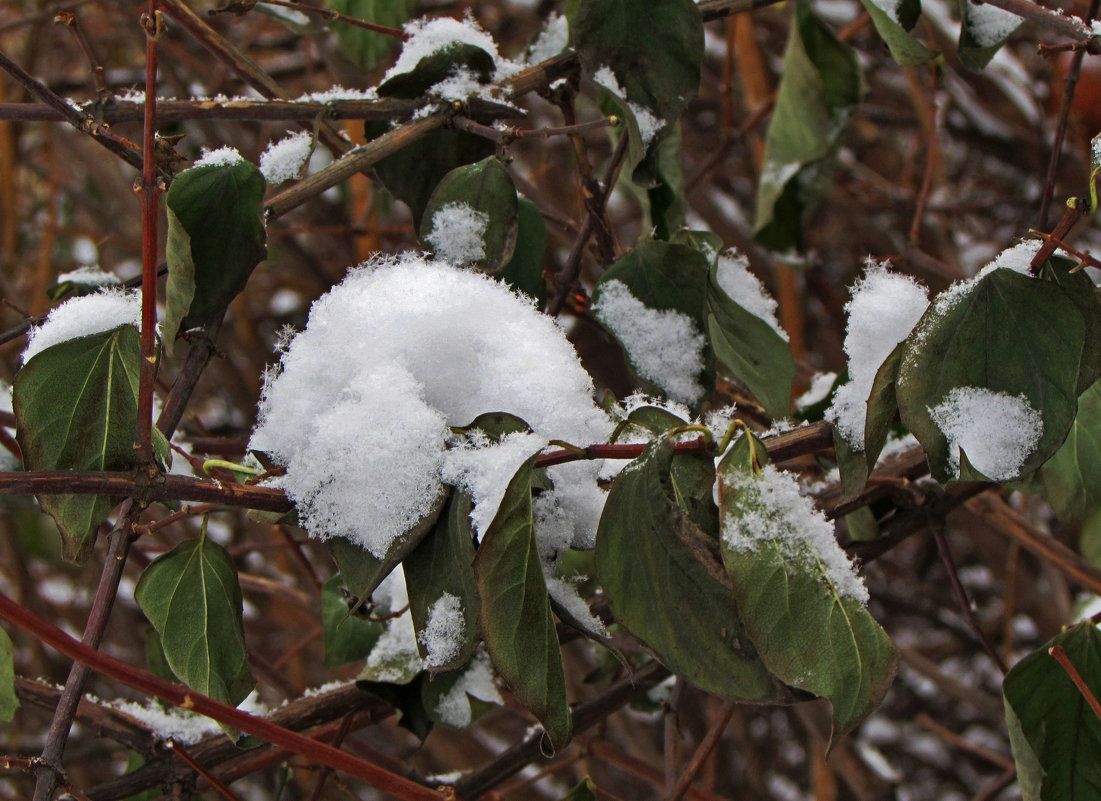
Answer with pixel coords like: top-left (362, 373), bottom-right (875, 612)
top-left (706, 259), bottom-right (795, 419)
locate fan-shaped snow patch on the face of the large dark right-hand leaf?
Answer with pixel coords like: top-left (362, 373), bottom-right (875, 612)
top-left (929, 386), bottom-right (1044, 481)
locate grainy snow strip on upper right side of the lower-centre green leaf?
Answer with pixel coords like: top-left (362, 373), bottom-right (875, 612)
top-left (721, 464), bottom-right (868, 604)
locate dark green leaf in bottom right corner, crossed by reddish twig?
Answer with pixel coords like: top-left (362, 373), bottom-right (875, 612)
top-left (1002, 621), bottom-right (1101, 801)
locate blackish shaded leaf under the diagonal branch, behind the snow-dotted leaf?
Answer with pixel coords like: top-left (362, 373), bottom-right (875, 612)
top-left (364, 120), bottom-right (497, 230)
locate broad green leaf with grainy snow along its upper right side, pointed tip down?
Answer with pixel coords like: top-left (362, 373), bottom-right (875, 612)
top-left (719, 446), bottom-right (898, 743)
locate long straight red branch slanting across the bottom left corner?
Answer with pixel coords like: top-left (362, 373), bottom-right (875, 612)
top-left (0, 594), bottom-right (445, 801)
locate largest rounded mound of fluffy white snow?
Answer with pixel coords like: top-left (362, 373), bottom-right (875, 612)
top-left (250, 254), bottom-right (613, 557)
